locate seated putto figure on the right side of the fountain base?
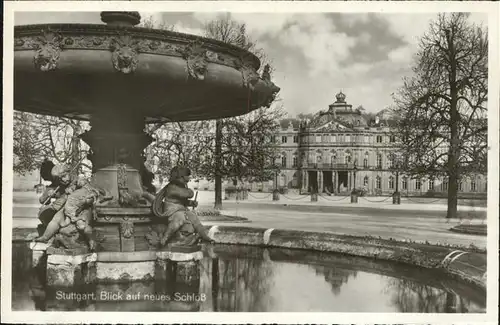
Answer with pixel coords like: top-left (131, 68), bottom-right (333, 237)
top-left (152, 166), bottom-right (213, 246)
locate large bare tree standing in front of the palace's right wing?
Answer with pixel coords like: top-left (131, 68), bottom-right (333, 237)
top-left (395, 13), bottom-right (488, 218)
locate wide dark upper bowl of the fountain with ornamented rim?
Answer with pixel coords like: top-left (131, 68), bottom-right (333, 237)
top-left (14, 24), bottom-right (279, 123)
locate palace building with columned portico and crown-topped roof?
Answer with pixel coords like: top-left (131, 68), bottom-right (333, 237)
top-left (260, 92), bottom-right (486, 195)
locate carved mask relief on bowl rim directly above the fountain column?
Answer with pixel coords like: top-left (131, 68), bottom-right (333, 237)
top-left (110, 34), bottom-right (140, 74)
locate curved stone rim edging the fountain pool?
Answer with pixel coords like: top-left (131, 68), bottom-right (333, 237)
top-left (12, 225), bottom-right (487, 290)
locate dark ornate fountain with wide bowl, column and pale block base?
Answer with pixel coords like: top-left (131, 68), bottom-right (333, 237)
top-left (14, 12), bottom-right (279, 298)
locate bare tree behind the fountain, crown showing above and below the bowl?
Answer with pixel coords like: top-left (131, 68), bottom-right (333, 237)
top-left (136, 14), bottom-right (284, 209)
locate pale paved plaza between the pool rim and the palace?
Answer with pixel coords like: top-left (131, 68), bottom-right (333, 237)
top-left (13, 191), bottom-right (486, 248)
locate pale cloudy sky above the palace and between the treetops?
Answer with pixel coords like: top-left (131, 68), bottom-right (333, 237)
top-left (15, 12), bottom-right (487, 116)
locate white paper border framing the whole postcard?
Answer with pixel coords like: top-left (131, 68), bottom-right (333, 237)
top-left (1, 1), bottom-right (500, 324)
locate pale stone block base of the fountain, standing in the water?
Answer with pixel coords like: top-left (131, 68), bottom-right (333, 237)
top-left (30, 243), bottom-right (203, 286)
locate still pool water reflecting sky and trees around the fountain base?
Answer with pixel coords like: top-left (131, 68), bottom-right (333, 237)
top-left (12, 244), bottom-right (486, 313)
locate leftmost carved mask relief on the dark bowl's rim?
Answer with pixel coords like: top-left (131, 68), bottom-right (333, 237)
top-left (32, 29), bottom-right (63, 71)
